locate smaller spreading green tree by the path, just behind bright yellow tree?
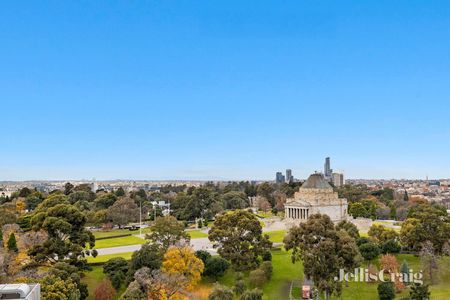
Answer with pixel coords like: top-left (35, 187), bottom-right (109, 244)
top-left (145, 216), bottom-right (190, 252)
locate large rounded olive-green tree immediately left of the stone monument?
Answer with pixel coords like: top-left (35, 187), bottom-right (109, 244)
top-left (209, 210), bottom-right (272, 270)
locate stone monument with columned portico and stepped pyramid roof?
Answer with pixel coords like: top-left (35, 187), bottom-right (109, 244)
top-left (285, 174), bottom-right (348, 222)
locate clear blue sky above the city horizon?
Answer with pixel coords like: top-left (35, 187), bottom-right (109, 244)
top-left (0, 0), bottom-right (450, 180)
